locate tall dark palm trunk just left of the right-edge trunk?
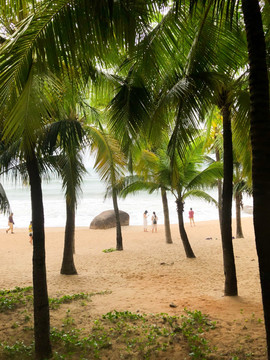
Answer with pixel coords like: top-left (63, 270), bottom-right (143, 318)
top-left (221, 100), bottom-right (238, 296)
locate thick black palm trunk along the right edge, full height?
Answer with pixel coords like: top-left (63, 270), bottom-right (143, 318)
top-left (242, 0), bottom-right (270, 360)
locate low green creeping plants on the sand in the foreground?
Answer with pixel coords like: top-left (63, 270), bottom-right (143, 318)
top-left (0, 287), bottom-right (263, 360)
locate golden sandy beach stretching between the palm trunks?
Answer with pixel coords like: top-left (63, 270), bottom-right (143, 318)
top-left (0, 218), bottom-right (266, 359)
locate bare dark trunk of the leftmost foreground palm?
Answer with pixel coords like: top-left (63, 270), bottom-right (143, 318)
top-left (26, 151), bottom-right (52, 360)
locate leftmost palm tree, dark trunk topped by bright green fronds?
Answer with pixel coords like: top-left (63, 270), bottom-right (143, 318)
top-left (1, 65), bottom-right (62, 359)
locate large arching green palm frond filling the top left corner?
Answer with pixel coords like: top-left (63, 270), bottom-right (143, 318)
top-left (0, 0), bottom-right (158, 109)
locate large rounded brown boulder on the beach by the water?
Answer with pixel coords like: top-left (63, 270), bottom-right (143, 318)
top-left (90, 210), bottom-right (129, 229)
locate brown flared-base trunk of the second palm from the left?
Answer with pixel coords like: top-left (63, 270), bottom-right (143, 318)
top-left (61, 200), bottom-right (77, 275)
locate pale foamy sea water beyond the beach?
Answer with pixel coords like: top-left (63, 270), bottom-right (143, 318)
top-left (0, 168), bottom-right (252, 228)
